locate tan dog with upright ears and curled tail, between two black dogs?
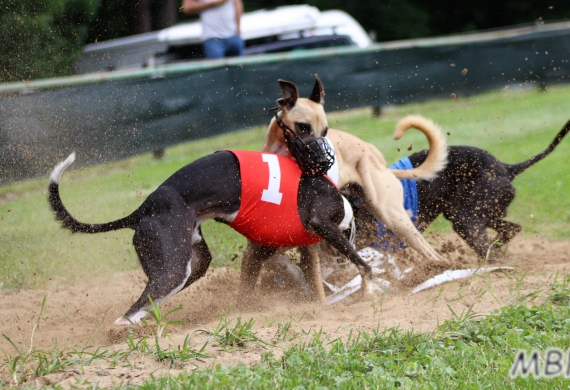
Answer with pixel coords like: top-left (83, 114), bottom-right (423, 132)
top-left (237, 76), bottom-right (447, 303)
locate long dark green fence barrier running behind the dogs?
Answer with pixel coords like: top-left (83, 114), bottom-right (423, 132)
top-left (0, 23), bottom-right (570, 183)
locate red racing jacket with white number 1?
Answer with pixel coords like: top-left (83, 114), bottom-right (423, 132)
top-left (225, 150), bottom-right (328, 247)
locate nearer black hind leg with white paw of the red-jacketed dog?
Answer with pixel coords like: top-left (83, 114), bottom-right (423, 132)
top-left (115, 206), bottom-right (194, 325)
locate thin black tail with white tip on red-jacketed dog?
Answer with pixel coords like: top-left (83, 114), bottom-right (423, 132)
top-left (48, 152), bottom-right (141, 233)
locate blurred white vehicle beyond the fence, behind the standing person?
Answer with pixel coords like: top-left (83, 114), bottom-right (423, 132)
top-left (75, 5), bottom-right (372, 73)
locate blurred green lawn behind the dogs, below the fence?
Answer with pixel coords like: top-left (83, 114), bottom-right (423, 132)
top-left (0, 86), bottom-right (570, 290)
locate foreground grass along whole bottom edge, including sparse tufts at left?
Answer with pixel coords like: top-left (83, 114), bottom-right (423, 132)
top-left (4, 275), bottom-right (570, 390)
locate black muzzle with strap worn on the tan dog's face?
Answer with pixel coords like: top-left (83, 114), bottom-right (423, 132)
top-left (275, 112), bottom-right (334, 176)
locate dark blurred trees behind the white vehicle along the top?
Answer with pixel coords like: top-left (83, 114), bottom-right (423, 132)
top-left (0, 0), bottom-right (570, 82)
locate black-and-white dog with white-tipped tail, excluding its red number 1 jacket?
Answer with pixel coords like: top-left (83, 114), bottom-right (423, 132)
top-left (49, 84), bottom-right (375, 325)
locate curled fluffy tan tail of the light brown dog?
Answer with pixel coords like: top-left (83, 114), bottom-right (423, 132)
top-left (391, 115), bottom-right (447, 180)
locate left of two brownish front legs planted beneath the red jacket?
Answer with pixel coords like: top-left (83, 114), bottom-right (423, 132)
top-left (240, 240), bottom-right (278, 303)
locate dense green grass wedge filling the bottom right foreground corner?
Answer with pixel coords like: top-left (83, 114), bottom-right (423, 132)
top-left (135, 277), bottom-right (570, 389)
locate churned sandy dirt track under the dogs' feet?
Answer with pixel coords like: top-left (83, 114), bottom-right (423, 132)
top-left (0, 234), bottom-right (570, 388)
